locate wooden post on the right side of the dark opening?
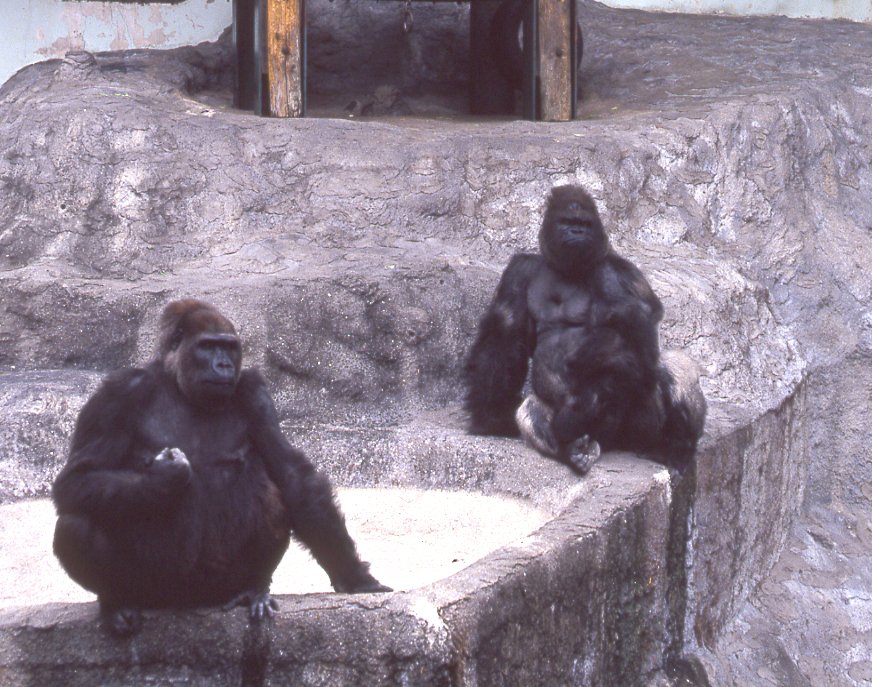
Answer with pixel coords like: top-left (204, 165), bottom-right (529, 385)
top-left (537, 0), bottom-right (577, 122)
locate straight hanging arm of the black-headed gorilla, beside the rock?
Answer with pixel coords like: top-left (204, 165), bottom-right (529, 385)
top-left (464, 254), bottom-right (543, 436)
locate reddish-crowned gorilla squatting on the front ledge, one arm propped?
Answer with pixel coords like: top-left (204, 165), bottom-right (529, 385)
top-left (52, 300), bottom-right (389, 636)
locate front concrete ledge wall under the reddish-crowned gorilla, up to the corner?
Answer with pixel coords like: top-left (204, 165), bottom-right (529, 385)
top-left (0, 454), bottom-right (671, 685)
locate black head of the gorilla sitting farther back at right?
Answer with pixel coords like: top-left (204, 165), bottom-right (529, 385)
top-left (539, 186), bottom-right (609, 277)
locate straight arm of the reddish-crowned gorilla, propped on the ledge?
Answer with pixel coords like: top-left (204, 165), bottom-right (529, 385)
top-left (238, 370), bottom-right (391, 593)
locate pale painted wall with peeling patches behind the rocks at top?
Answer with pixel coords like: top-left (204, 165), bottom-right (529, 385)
top-left (0, 0), bottom-right (872, 83)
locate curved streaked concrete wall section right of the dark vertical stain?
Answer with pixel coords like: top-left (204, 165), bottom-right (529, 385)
top-left (686, 384), bottom-right (808, 649)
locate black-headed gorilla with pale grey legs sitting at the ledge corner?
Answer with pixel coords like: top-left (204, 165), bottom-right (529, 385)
top-left (465, 186), bottom-right (706, 474)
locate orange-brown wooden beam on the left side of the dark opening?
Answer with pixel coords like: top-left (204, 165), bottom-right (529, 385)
top-left (263, 0), bottom-right (306, 117)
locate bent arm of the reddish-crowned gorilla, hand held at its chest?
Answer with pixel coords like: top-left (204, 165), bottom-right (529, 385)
top-left (52, 369), bottom-right (191, 520)
